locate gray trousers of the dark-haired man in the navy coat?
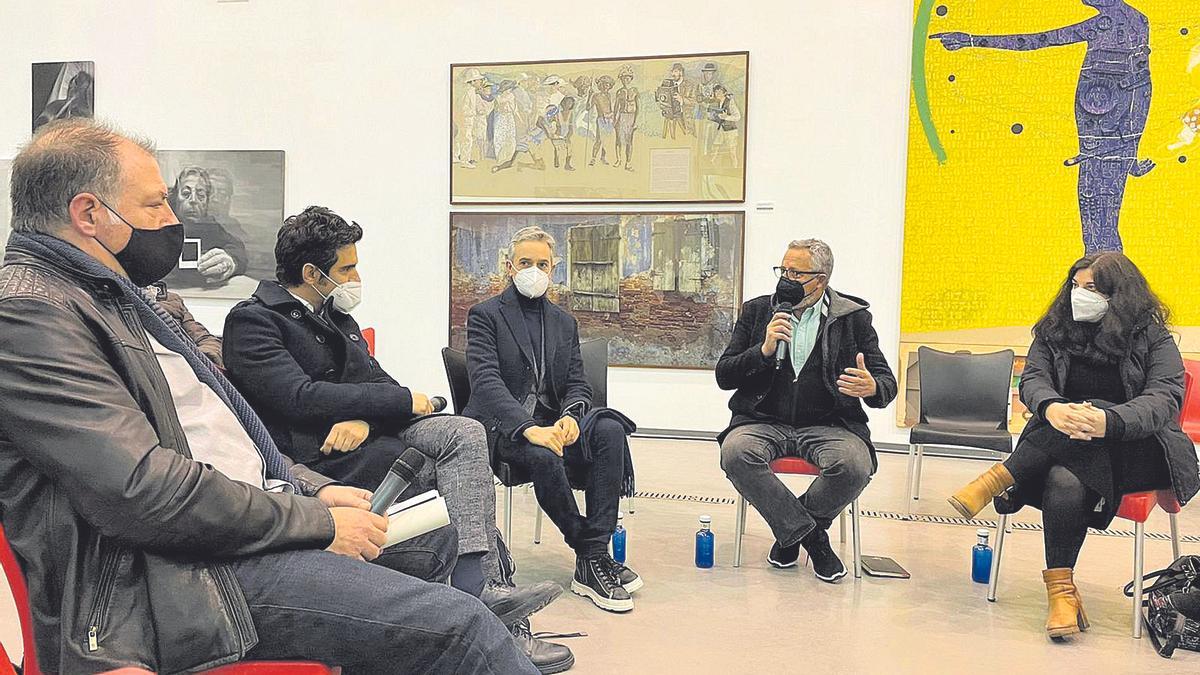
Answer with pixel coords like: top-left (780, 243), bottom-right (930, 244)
top-left (396, 416), bottom-right (511, 580)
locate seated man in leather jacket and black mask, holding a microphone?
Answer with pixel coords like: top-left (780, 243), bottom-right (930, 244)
top-left (0, 119), bottom-right (536, 674)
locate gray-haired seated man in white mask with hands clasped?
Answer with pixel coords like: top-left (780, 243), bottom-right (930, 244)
top-left (463, 227), bottom-right (642, 611)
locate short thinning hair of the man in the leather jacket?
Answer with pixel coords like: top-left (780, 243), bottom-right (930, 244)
top-left (10, 118), bottom-right (155, 234)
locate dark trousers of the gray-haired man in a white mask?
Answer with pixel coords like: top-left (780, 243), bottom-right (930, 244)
top-left (496, 419), bottom-right (625, 557)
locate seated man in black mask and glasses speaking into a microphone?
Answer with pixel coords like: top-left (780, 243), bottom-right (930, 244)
top-left (716, 239), bottom-right (896, 584)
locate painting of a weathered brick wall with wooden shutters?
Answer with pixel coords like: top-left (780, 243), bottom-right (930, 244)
top-left (450, 211), bottom-right (745, 370)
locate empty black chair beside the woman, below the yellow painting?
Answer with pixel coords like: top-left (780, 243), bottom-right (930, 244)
top-left (907, 347), bottom-right (1013, 514)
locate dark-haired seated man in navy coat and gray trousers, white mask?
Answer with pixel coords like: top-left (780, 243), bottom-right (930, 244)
top-left (223, 207), bottom-right (570, 668)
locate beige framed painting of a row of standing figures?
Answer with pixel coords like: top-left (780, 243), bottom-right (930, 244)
top-left (450, 52), bottom-right (750, 204)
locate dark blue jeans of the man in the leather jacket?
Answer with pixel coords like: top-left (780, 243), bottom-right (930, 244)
top-left (233, 533), bottom-right (538, 675)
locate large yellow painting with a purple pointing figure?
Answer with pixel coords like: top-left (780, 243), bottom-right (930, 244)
top-left (900, 0), bottom-right (1200, 426)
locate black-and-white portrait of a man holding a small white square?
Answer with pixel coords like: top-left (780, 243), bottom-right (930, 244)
top-left (158, 150), bottom-right (283, 299)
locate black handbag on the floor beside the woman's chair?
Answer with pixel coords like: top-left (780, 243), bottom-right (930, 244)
top-left (1124, 555), bottom-right (1200, 658)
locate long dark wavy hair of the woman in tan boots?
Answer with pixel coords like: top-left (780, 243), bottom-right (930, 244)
top-left (1033, 251), bottom-right (1170, 358)
